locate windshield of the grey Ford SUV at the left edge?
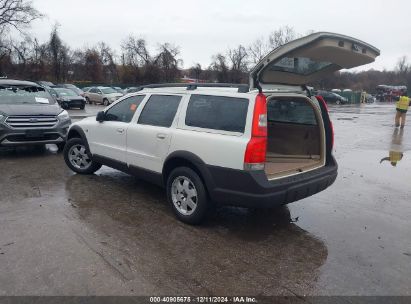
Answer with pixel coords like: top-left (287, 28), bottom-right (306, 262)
top-left (0, 85), bottom-right (55, 105)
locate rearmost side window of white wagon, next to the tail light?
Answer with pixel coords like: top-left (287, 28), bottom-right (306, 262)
top-left (185, 94), bottom-right (248, 133)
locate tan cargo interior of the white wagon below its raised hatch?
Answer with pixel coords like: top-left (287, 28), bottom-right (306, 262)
top-left (265, 97), bottom-right (324, 179)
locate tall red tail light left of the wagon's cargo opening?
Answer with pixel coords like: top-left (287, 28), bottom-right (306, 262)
top-left (244, 93), bottom-right (267, 170)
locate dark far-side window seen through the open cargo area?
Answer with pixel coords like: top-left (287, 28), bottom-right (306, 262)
top-left (267, 99), bottom-right (318, 125)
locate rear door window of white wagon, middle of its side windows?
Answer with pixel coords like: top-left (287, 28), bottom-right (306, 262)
top-left (138, 95), bottom-right (181, 128)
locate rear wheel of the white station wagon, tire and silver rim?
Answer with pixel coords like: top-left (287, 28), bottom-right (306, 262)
top-left (166, 167), bottom-right (211, 225)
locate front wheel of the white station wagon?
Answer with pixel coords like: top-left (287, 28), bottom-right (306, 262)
top-left (63, 137), bottom-right (101, 174)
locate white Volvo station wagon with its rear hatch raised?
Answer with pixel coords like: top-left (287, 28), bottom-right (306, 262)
top-left (64, 33), bottom-right (380, 224)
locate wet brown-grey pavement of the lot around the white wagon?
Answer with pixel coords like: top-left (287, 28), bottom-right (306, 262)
top-left (0, 104), bottom-right (411, 295)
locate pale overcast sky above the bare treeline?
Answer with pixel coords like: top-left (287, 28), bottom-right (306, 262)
top-left (31, 0), bottom-right (411, 70)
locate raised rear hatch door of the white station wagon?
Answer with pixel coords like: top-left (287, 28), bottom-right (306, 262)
top-left (250, 32), bottom-right (380, 89)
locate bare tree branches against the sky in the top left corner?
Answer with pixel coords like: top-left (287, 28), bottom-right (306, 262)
top-left (0, 0), bottom-right (43, 33)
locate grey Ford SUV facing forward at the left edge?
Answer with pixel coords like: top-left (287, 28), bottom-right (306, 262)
top-left (0, 79), bottom-right (71, 149)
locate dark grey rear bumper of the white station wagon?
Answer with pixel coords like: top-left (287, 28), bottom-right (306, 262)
top-left (206, 157), bottom-right (338, 208)
